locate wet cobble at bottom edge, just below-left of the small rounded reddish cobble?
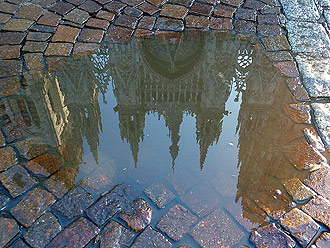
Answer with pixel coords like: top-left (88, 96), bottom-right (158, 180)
top-left (99, 220), bottom-right (134, 248)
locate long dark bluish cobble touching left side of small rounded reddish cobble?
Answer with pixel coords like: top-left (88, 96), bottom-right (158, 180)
top-left (85, 184), bottom-right (135, 226)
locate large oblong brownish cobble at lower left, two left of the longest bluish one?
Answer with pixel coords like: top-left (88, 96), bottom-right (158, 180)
top-left (10, 188), bottom-right (55, 227)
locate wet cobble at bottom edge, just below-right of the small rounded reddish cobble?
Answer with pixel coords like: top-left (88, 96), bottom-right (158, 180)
top-left (131, 226), bottom-right (172, 248)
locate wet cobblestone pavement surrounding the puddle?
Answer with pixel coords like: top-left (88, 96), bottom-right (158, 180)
top-left (0, 0), bottom-right (330, 247)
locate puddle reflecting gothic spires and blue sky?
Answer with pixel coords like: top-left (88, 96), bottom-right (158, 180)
top-left (0, 32), bottom-right (314, 247)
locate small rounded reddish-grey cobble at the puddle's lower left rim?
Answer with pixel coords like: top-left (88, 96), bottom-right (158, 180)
top-left (118, 198), bottom-right (152, 232)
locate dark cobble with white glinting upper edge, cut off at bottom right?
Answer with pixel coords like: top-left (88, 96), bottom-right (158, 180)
top-left (250, 223), bottom-right (296, 248)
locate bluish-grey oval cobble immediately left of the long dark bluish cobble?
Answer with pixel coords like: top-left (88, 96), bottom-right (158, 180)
top-left (53, 186), bottom-right (94, 219)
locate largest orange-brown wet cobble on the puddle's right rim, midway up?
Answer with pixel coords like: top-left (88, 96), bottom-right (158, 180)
top-left (284, 140), bottom-right (324, 170)
